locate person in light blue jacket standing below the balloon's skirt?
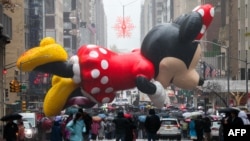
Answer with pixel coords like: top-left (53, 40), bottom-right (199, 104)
top-left (66, 112), bottom-right (86, 141)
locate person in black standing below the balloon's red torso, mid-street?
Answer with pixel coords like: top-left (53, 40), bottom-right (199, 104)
top-left (113, 111), bottom-right (129, 141)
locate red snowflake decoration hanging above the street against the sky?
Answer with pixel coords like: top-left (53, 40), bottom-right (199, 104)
top-left (113, 16), bottom-right (135, 38)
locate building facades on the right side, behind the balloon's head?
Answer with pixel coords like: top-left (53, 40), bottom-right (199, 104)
top-left (141, 0), bottom-right (250, 107)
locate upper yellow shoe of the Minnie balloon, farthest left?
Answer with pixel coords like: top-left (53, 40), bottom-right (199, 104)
top-left (16, 37), bottom-right (68, 71)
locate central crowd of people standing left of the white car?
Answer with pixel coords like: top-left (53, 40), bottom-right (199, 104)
top-left (34, 109), bottom-right (161, 141)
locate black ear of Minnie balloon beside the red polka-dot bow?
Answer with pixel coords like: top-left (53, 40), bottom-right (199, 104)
top-left (174, 12), bottom-right (203, 42)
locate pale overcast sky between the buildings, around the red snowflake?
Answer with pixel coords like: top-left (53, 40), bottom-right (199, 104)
top-left (103, 0), bottom-right (142, 52)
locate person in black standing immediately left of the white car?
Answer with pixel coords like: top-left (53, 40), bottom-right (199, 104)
top-left (145, 109), bottom-right (161, 141)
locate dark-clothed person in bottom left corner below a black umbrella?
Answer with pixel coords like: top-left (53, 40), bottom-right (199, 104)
top-left (3, 120), bottom-right (18, 141)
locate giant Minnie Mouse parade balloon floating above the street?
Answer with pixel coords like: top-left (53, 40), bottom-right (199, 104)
top-left (16, 4), bottom-right (214, 116)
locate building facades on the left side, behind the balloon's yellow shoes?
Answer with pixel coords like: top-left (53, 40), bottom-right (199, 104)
top-left (0, 0), bottom-right (107, 116)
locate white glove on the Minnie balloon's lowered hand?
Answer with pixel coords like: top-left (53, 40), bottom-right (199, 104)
top-left (148, 81), bottom-right (166, 108)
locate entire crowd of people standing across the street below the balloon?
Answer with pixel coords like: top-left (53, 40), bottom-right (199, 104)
top-left (3, 108), bottom-right (250, 141)
